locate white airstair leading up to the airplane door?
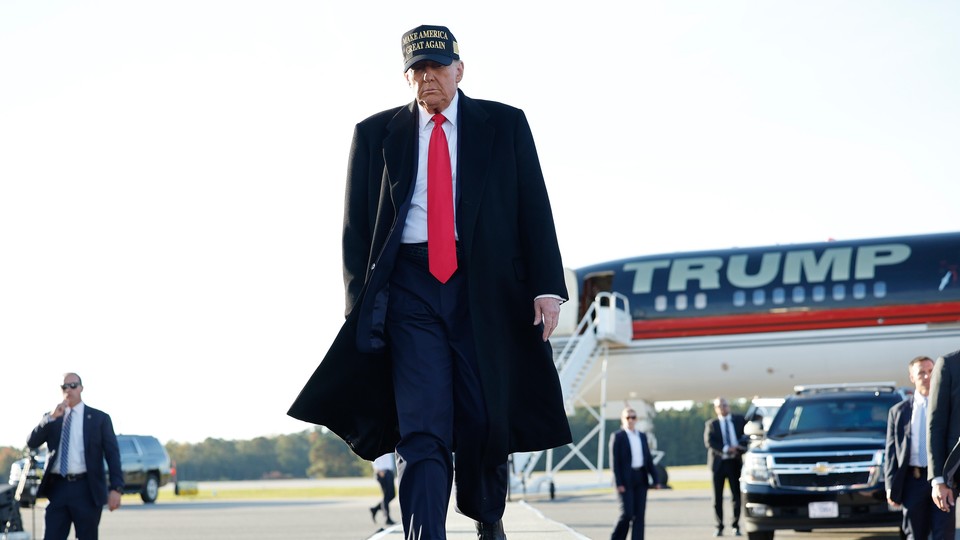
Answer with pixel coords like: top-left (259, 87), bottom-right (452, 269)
top-left (510, 292), bottom-right (633, 498)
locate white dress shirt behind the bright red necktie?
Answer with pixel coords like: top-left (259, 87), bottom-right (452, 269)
top-left (400, 92), bottom-right (460, 244)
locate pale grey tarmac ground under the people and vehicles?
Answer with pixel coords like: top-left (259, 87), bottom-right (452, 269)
top-left (0, 470), bottom-right (932, 540)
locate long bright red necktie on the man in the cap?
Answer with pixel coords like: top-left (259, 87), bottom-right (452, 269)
top-left (427, 114), bottom-right (457, 283)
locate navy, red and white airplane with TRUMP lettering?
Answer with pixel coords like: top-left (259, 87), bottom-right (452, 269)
top-left (551, 232), bottom-right (960, 408)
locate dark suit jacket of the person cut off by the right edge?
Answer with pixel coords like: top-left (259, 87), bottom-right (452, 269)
top-left (927, 351), bottom-right (960, 480)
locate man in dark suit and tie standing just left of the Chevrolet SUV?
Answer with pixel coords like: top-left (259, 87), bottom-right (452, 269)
top-left (703, 397), bottom-right (747, 536)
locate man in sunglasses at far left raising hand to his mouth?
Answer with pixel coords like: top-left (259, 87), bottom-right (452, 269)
top-left (27, 373), bottom-right (123, 540)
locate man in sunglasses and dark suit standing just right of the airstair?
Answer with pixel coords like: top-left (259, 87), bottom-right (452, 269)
top-left (610, 407), bottom-right (660, 540)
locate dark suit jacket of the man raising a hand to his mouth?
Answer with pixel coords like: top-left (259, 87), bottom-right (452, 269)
top-left (27, 404), bottom-right (123, 506)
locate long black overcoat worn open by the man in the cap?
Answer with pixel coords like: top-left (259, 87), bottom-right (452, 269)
top-left (288, 92), bottom-right (571, 463)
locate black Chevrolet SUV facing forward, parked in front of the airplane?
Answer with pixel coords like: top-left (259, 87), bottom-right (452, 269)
top-left (740, 383), bottom-right (906, 540)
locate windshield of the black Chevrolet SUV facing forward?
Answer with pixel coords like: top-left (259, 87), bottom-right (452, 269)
top-left (767, 396), bottom-right (900, 437)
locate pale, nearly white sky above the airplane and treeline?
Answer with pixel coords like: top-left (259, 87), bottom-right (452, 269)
top-left (0, 0), bottom-right (960, 447)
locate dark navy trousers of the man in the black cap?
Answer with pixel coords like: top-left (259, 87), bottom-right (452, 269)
top-left (386, 255), bottom-right (508, 540)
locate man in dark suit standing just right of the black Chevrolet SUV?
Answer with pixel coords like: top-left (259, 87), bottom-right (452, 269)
top-left (884, 356), bottom-right (956, 540)
